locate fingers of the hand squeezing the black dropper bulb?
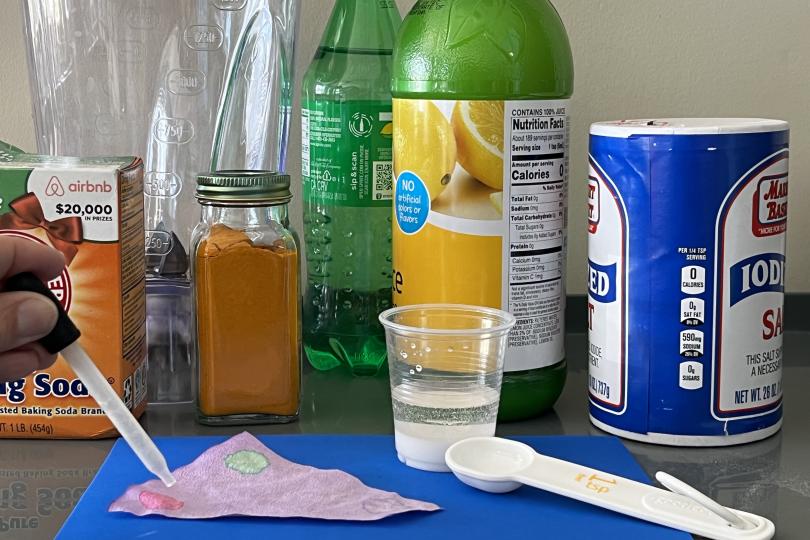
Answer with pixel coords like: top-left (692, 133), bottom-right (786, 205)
top-left (0, 235), bottom-right (65, 383)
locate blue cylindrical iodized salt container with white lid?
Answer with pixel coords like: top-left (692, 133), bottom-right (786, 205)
top-left (588, 119), bottom-right (790, 446)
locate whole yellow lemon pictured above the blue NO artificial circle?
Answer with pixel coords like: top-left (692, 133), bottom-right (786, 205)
top-left (394, 99), bottom-right (456, 200)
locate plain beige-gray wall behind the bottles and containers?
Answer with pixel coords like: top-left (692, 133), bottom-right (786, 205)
top-left (0, 0), bottom-right (810, 293)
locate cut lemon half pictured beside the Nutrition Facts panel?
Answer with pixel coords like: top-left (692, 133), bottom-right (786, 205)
top-left (452, 101), bottom-right (503, 191)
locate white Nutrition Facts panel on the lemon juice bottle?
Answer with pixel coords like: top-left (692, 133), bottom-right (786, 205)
top-left (504, 100), bottom-right (568, 370)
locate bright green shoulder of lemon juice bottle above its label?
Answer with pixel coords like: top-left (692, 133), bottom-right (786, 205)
top-left (392, 0), bottom-right (574, 99)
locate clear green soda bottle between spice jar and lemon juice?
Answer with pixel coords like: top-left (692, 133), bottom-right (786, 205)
top-left (301, 0), bottom-right (402, 375)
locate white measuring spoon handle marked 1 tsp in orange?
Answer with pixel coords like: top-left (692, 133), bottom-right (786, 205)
top-left (511, 454), bottom-right (775, 540)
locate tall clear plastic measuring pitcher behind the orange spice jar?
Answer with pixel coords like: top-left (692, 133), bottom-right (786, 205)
top-left (23, 0), bottom-right (297, 402)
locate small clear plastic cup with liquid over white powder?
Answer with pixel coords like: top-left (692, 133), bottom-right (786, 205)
top-left (380, 304), bottom-right (515, 471)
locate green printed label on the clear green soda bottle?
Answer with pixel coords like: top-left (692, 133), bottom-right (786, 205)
top-left (301, 100), bottom-right (393, 207)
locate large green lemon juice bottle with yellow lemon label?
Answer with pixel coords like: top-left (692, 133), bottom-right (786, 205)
top-left (392, 0), bottom-right (573, 420)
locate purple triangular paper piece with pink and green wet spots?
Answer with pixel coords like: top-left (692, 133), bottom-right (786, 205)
top-left (109, 432), bottom-right (439, 521)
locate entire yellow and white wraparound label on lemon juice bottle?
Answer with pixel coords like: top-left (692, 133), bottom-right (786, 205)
top-left (393, 99), bottom-right (569, 371)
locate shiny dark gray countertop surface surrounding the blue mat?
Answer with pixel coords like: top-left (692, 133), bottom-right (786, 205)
top-left (0, 332), bottom-right (810, 540)
